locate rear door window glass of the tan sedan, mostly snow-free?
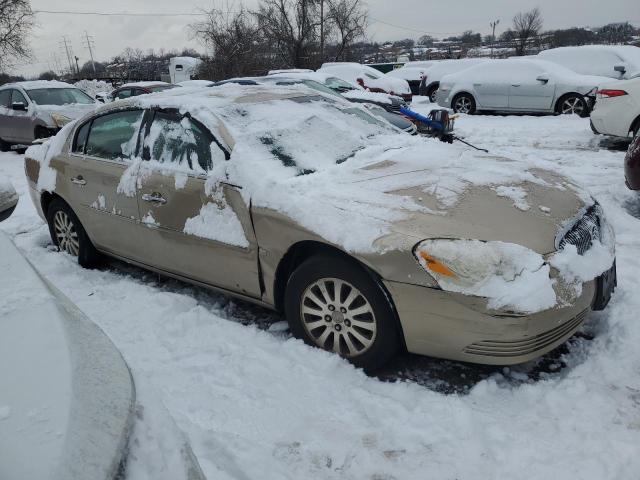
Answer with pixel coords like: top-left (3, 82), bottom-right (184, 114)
top-left (85, 110), bottom-right (143, 160)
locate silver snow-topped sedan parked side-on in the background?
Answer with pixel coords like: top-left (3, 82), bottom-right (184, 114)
top-left (437, 59), bottom-right (610, 116)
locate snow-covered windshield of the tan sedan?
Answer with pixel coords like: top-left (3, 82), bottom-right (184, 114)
top-left (220, 95), bottom-right (403, 175)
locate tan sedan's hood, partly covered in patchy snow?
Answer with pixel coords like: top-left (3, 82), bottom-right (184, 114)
top-left (348, 151), bottom-right (594, 255)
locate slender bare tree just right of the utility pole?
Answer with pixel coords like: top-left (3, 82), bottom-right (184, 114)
top-left (320, 0), bottom-right (368, 61)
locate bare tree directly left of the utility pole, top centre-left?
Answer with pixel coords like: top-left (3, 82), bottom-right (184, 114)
top-left (256, 0), bottom-right (321, 68)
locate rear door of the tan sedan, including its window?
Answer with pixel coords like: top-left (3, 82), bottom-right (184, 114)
top-left (62, 110), bottom-right (144, 260)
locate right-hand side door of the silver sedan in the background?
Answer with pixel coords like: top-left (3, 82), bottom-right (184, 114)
top-left (509, 63), bottom-right (556, 111)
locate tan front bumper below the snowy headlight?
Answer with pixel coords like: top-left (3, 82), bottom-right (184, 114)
top-left (385, 280), bottom-right (596, 365)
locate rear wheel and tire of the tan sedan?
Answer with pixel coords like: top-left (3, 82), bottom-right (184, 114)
top-left (47, 198), bottom-right (100, 268)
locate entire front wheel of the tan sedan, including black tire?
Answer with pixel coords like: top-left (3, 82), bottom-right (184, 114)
top-left (285, 254), bottom-right (400, 372)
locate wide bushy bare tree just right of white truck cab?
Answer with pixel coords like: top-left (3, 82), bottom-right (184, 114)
top-left (191, 5), bottom-right (269, 80)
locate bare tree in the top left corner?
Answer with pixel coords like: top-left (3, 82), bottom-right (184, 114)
top-left (0, 0), bottom-right (34, 70)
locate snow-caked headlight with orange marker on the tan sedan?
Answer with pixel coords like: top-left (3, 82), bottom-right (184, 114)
top-left (414, 239), bottom-right (556, 313)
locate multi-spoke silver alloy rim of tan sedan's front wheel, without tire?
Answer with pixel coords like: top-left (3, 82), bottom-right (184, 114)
top-left (300, 278), bottom-right (378, 357)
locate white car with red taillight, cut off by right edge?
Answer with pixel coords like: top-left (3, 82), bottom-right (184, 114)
top-left (591, 74), bottom-right (640, 137)
